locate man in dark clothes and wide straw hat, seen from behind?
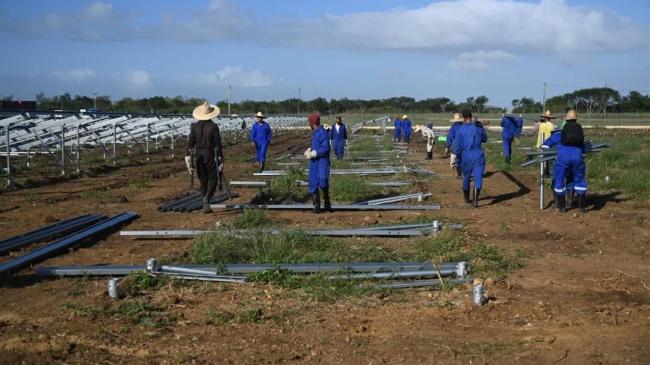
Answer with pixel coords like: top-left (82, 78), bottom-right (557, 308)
top-left (185, 101), bottom-right (223, 213)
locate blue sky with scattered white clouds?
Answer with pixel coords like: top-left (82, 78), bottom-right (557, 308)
top-left (0, 0), bottom-right (650, 107)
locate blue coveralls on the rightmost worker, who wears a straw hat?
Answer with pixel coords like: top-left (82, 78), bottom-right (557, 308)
top-left (542, 131), bottom-right (587, 196)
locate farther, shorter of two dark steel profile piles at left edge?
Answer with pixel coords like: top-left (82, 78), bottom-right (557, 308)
top-left (0, 213), bottom-right (106, 255)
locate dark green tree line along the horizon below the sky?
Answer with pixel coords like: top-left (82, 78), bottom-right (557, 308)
top-left (2, 87), bottom-right (650, 115)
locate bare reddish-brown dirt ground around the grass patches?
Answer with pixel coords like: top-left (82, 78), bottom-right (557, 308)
top-left (0, 129), bottom-right (650, 364)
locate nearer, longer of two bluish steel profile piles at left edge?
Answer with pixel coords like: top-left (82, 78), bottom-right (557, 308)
top-left (0, 212), bottom-right (138, 274)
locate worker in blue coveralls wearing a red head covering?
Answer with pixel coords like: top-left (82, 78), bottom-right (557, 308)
top-left (305, 113), bottom-right (332, 213)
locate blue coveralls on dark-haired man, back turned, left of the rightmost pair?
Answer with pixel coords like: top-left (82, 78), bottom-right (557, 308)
top-left (454, 123), bottom-right (487, 190)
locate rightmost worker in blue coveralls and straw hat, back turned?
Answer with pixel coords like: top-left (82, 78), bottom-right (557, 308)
top-left (542, 110), bottom-right (587, 213)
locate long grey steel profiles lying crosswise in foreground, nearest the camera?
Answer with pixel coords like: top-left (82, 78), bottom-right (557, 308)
top-left (36, 261), bottom-right (469, 276)
